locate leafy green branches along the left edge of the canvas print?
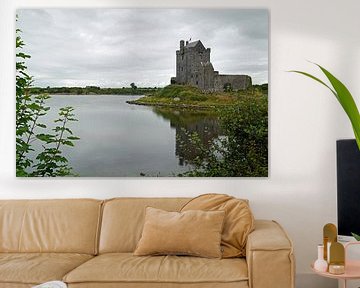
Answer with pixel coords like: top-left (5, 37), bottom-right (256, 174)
top-left (16, 25), bottom-right (80, 177)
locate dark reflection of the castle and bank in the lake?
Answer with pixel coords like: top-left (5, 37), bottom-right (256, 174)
top-left (153, 108), bottom-right (221, 166)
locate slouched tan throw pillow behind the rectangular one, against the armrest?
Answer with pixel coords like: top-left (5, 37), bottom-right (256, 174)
top-left (181, 194), bottom-right (254, 258)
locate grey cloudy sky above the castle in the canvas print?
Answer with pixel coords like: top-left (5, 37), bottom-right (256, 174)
top-left (17, 9), bottom-right (268, 87)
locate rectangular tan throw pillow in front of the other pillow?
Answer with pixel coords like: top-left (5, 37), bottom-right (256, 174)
top-left (134, 207), bottom-right (225, 258)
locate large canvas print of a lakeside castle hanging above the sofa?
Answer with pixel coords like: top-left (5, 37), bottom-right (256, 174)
top-left (16, 9), bottom-right (269, 177)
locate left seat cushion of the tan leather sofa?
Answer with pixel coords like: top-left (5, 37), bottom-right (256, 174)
top-left (0, 253), bottom-right (93, 285)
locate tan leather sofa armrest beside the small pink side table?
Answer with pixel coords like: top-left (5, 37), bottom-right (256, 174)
top-left (246, 220), bottom-right (295, 288)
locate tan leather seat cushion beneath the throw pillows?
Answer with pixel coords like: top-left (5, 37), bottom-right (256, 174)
top-left (64, 253), bottom-right (248, 287)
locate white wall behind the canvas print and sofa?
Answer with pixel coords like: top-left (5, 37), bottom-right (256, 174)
top-left (0, 0), bottom-right (360, 288)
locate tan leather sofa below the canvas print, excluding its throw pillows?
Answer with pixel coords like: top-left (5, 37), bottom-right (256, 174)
top-left (0, 198), bottom-right (294, 288)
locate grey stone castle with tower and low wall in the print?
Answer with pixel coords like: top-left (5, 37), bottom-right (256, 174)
top-left (171, 40), bottom-right (252, 92)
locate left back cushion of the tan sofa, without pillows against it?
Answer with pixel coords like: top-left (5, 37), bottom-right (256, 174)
top-left (0, 199), bottom-right (103, 254)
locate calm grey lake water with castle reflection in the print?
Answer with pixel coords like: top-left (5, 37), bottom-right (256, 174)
top-left (34, 95), bottom-right (219, 177)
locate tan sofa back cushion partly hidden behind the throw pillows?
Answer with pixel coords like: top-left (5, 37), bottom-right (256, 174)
top-left (99, 198), bottom-right (190, 253)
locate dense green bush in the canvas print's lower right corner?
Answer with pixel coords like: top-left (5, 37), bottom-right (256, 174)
top-left (181, 96), bottom-right (268, 177)
